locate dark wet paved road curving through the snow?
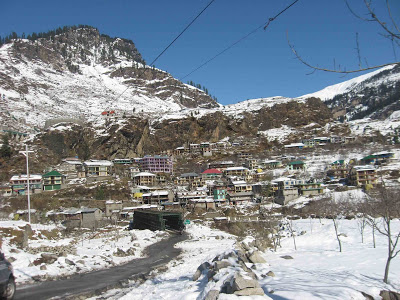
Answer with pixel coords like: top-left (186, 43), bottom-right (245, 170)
top-left (15, 234), bottom-right (187, 300)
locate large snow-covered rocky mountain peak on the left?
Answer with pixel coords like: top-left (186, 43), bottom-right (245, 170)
top-left (0, 26), bottom-right (218, 129)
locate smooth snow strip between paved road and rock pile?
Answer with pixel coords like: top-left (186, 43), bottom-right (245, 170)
top-left (95, 224), bottom-right (236, 300)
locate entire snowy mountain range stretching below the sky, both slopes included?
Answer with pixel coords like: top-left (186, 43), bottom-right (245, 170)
top-left (0, 26), bottom-right (400, 137)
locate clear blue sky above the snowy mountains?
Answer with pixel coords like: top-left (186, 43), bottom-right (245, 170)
top-left (0, 0), bottom-right (400, 104)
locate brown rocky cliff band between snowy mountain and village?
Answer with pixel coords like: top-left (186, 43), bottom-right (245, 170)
top-left (28, 98), bottom-right (332, 163)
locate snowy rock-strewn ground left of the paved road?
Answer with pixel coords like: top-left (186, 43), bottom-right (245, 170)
top-left (0, 221), bottom-right (167, 284)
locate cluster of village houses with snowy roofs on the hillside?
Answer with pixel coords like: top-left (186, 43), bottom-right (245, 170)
top-left (0, 132), bottom-right (395, 226)
